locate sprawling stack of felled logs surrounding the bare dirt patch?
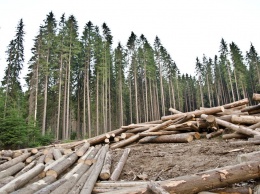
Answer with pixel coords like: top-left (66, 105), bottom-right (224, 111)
top-left (0, 94), bottom-right (260, 194)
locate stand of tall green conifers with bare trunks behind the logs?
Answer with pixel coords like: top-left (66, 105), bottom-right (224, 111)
top-left (0, 12), bottom-right (260, 147)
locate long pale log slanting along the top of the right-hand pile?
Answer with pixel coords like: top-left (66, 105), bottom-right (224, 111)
top-left (161, 106), bottom-right (224, 121)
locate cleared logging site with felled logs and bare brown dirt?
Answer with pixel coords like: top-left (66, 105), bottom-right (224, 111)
top-left (0, 93), bottom-right (260, 194)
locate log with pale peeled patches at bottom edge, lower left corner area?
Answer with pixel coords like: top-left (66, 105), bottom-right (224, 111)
top-left (12, 176), bottom-right (56, 194)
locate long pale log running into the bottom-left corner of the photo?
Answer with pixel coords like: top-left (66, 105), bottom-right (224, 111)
top-left (0, 164), bottom-right (44, 193)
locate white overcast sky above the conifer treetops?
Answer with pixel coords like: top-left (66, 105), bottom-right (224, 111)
top-left (0, 0), bottom-right (260, 88)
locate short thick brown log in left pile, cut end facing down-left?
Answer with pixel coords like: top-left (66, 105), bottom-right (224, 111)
top-left (46, 153), bottom-right (78, 178)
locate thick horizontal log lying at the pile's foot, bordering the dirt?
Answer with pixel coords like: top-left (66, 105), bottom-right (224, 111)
top-left (139, 133), bottom-right (193, 143)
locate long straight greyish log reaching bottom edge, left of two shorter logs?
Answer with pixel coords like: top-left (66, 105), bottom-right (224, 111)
top-left (80, 145), bottom-right (109, 194)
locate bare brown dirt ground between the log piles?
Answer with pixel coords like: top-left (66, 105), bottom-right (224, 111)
top-left (109, 138), bottom-right (260, 185)
